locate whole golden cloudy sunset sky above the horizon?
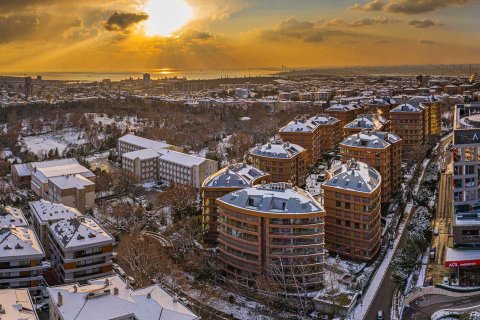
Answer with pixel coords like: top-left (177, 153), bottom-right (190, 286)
top-left (0, 0), bottom-right (480, 73)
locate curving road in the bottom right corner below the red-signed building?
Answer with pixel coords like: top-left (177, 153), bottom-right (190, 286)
top-left (403, 295), bottom-right (480, 320)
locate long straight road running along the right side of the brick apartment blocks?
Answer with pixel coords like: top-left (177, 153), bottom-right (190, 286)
top-left (365, 135), bottom-right (453, 320)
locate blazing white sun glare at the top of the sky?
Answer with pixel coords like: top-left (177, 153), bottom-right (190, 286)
top-left (143, 0), bottom-right (192, 36)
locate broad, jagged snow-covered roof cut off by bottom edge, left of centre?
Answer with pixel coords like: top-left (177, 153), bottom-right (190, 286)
top-left (48, 275), bottom-right (199, 320)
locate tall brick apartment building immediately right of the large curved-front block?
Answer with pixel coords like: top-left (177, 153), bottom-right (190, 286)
top-left (322, 160), bottom-right (382, 262)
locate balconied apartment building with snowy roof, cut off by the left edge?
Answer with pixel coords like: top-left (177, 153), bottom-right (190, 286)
top-left (0, 225), bottom-right (45, 296)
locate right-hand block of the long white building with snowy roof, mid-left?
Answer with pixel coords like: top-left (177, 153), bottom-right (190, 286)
top-left (158, 150), bottom-right (218, 189)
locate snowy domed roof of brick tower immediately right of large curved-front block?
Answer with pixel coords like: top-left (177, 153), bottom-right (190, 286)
top-left (324, 160), bottom-right (381, 193)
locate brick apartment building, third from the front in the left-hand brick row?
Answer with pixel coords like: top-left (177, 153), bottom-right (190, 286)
top-left (249, 140), bottom-right (307, 186)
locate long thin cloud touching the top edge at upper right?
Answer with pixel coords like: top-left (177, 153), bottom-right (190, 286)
top-left (352, 0), bottom-right (470, 14)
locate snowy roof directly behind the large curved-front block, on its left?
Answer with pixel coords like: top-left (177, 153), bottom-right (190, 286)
top-left (203, 163), bottom-right (269, 188)
